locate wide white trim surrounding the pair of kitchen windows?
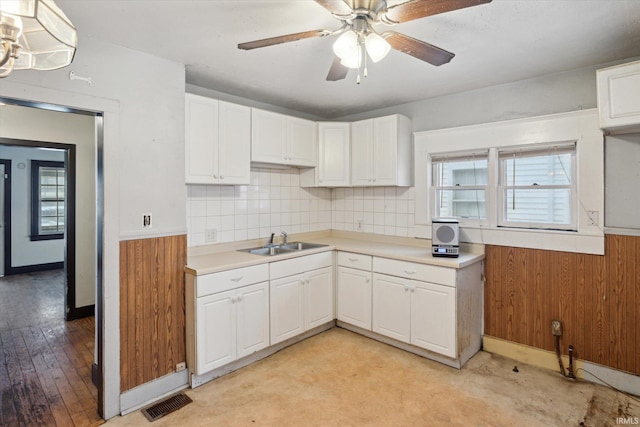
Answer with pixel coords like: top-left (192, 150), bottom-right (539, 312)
top-left (414, 109), bottom-right (604, 255)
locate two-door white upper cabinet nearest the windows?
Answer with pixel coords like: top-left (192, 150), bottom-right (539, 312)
top-left (351, 114), bottom-right (412, 187)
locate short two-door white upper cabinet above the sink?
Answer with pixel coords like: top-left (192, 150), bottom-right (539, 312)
top-left (251, 108), bottom-right (317, 167)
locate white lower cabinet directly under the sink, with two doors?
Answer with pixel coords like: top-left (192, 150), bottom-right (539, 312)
top-left (270, 252), bottom-right (335, 345)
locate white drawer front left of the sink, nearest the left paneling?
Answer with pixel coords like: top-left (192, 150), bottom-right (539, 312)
top-left (196, 264), bottom-right (269, 297)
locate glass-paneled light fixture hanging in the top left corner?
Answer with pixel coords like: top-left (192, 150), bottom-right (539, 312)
top-left (0, 0), bottom-right (78, 77)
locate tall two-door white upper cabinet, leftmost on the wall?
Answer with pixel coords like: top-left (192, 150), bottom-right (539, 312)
top-left (185, 94), bottom-right (251, 185)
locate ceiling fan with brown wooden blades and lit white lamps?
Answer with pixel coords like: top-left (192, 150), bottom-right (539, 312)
top-left (238, 0), bottom-right (491, 83)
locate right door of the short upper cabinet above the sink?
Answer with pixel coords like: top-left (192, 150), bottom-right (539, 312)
top-left (285, 117), bottom-right (318, 167)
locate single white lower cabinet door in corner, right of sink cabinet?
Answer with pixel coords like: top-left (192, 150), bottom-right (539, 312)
top-left (338, 267), bottom-right (371, 331)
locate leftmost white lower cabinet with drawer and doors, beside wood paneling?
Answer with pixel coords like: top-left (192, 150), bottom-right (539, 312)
top-left (186, 264), bottom-right (270, 375)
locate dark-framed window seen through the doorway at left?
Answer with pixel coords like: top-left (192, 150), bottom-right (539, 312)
top-left (31, 160), bottom-right (65, 240)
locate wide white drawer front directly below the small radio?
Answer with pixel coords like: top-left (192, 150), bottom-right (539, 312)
top-left (373, 257), bottom-right (456, 287)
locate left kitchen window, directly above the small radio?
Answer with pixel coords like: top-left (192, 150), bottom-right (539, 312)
top-left (431, 152), bottom-right (488, 220)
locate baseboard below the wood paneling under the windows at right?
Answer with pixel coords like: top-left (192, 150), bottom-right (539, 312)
top-left (482, 336), bottom-right (640, 396)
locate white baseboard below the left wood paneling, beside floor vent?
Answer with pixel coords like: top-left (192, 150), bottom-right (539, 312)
top-left (120, 369), bottom-right (189, 415)
